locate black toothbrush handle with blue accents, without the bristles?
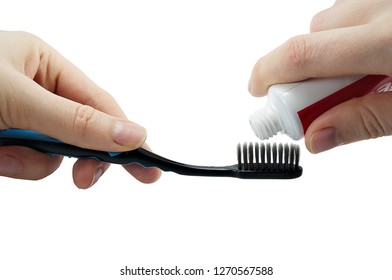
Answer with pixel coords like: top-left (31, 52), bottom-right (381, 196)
top-left (0, 129), bottom-right (302, 179)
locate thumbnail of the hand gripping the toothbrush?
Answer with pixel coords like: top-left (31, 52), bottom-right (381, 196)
top-left (113, 122), bottom-right (147, 147)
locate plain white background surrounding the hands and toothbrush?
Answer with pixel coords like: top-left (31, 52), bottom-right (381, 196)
top-left (0, 0), bottom-right (392, 280)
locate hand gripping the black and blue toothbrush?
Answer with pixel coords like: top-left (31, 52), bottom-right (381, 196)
top-left (0, 31), bottom-right (160, 188)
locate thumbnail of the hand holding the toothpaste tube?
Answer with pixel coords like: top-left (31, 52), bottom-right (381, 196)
top-left (310, 127), bottom-right (343, 154)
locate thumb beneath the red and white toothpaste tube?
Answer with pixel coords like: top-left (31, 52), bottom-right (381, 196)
top-left (305, 92), bottom-right (392, 153)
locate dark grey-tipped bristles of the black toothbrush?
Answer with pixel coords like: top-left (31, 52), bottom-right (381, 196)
top-left (237, 143), bottom-right (299, 171)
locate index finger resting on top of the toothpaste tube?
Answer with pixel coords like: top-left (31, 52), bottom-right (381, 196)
top-left (249, 25), bottom-right (382, 96)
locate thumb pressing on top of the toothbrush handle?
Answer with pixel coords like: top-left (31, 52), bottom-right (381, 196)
top-left (1, 71), bottom-right (146, 151)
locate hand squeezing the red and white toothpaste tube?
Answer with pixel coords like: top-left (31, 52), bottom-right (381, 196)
top-left (249, 0), bottom-right (392, 153)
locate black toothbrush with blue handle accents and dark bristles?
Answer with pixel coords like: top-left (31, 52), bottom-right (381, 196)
top-left (0, 129), bottom-right (302, 179)
